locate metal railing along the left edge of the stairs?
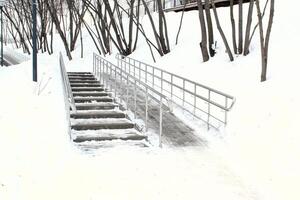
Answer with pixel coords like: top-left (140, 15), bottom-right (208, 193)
top-left (59, 52), bottom-right (76, 138)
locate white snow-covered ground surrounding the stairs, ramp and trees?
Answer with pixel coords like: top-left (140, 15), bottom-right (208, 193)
top-left (0, 0), bottom-right (300, 200)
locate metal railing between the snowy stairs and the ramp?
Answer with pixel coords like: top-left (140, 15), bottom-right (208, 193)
top-left (93, 53), bottom-right (168, 147)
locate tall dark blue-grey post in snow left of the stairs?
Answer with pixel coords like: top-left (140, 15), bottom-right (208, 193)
top-left (32, 0), bottom-right (37, 82)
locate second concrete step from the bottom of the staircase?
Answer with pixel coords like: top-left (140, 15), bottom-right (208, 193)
top-left (71, 118), bottom-right (134, 130)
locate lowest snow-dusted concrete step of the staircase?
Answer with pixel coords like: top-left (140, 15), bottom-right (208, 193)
top-left (73, 129), bottom-right (147, 143)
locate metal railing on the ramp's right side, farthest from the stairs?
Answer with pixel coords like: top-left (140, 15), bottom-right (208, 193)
top-left (116, 54), bottom-right (235, 129)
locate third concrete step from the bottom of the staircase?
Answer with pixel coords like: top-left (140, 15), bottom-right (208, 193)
top-left (70, 110), bottom-right (126, 119)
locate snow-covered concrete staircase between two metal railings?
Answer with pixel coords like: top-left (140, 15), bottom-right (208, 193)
top-left (68, 72), bottom-right (147, 147)
